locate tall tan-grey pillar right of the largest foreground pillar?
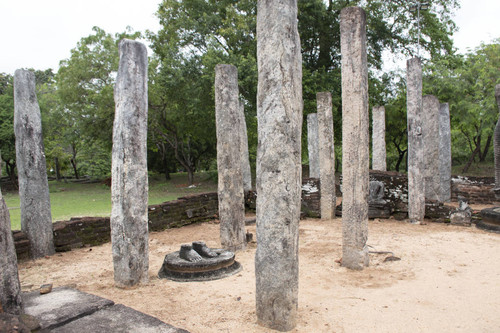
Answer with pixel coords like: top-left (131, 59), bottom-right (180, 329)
top-left (340, 7), bottom-right (370, 270)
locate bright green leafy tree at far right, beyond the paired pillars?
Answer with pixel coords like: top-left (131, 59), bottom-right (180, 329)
top-left (424, 39), bottom-right (500, 172)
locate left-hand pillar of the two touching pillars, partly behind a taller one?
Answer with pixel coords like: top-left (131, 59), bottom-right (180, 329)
top-left (422, 95), bottom-right (441, 200)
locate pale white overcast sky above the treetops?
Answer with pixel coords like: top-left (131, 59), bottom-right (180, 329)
top-left (0, 0), bottom-right (500, 74)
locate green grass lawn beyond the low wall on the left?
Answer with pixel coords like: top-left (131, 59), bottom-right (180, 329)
top-left (2, 173), bottom-right (217, 230)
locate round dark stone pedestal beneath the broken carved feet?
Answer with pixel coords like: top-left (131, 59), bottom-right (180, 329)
top-left (158, 249), bottom-right (241, 282)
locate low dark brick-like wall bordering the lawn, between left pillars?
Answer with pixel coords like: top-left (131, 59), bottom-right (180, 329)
top-left (12, 193), bottom-right (218, 260)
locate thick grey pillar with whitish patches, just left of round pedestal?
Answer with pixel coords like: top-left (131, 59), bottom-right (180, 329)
top-left (111, 39), bottom-right (149, 287)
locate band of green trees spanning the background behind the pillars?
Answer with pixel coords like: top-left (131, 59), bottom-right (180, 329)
top-left (0, 0), bottom-right (500, 182)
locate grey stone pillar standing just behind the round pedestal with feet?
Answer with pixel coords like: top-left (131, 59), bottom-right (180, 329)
top-left (215, 65), bottom-right (246, 251)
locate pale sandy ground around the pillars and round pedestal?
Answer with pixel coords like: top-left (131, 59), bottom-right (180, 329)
top-left (19, 208), bottom-right (500, 333)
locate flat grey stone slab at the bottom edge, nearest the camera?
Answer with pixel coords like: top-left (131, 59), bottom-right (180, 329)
top-left (51, 304), bottom-right (189, 333)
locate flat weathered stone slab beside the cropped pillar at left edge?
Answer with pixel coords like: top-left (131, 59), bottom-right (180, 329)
top-left (23, 287), bottom-right (114, 332)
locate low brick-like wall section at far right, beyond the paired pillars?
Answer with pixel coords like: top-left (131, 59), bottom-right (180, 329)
top-left (451, 176), bottom-right (498, 205)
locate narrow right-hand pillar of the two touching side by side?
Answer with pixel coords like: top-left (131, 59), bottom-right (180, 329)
top-left (439, 103), bottom-right (451, 202)
